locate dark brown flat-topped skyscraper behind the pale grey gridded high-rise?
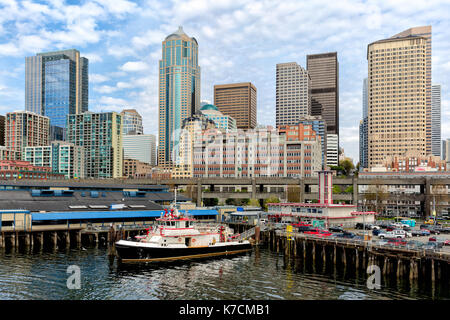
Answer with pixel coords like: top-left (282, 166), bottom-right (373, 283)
top-left (306, 52), bottom-right (339, 135)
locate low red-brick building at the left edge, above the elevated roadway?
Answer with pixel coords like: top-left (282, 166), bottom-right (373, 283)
top-left (0, 160), bottom-right (64, 180)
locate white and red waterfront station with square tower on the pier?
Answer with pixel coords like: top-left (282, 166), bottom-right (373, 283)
top-left (267, 171), bottom-right (377, 227)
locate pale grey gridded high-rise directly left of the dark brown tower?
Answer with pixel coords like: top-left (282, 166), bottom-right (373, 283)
top-left (275, 62), bottom-right (312, 128)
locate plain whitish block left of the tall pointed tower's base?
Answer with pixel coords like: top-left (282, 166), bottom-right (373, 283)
top-left (122, 134), bottom-right (156, 166)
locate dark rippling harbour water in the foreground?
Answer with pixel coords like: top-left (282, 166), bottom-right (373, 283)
top-left (0, 248), bottom-right (450, 300)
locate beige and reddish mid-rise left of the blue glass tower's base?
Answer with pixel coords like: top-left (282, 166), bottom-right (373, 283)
top-left (5, 111), bottom-right (50, 160)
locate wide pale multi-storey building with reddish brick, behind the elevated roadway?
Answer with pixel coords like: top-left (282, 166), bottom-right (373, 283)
top-left (189, 124), bottom-right (322, 178)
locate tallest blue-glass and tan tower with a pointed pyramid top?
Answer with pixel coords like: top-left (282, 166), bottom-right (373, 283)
top-left (158, 27), bottom-right (200, 167)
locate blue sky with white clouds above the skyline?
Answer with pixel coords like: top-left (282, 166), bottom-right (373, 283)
top-left (0, 0), bottom-right (450, 164)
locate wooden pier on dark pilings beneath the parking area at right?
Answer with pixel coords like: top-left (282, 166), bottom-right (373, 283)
top-left (259, 229), bottom-right (450, 283)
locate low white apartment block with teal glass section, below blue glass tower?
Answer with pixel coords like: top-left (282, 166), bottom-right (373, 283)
top-left (25, 141), bottom-right (85, 179)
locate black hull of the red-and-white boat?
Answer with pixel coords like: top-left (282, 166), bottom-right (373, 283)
top-left (115, 243), bottom-right (252, 263)
